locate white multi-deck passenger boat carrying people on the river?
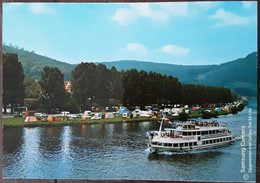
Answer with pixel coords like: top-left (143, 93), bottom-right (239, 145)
top-left (149, 120), bottom-right (235, 152)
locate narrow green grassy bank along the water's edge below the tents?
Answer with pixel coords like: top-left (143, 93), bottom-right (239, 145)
top-left (2, 101), bottom-right (248, 127)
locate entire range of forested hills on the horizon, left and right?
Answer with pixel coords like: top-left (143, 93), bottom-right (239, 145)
top-left (3, 46), bottom-right (257, 96)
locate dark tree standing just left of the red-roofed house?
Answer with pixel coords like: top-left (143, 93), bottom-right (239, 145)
top-left (39, 67), bottom-right (66, 112)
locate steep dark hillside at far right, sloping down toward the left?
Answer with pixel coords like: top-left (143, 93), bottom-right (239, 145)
top-left (196, 52), bottom-right (257, 96)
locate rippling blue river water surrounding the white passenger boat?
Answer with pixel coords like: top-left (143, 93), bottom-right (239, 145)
top-left (3, 101), bottom-right (257, 181)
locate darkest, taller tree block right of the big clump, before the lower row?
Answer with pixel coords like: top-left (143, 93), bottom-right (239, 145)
top-left (122, 69), bottom-right (181, 107)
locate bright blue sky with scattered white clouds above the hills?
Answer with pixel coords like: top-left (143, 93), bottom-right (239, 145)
top-left (3, 1), bottom-right (257, 65)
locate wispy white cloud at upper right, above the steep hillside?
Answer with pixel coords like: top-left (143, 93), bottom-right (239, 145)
top-left (210, 9), bottom-right (250, 27)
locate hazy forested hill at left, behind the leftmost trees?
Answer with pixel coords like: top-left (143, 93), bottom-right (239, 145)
top-left (2, 45), bottom-right (76, 80)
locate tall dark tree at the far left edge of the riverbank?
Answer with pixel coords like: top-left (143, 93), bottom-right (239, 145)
top-left (3, 53), bottom-right (24, 113)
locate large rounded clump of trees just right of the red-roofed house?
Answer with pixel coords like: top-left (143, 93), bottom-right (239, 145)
top-left (71, 63), bottom-right (122, 110)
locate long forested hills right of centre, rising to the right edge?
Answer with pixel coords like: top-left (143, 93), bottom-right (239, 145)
top-left (100, 52), bottom-right (257, 96)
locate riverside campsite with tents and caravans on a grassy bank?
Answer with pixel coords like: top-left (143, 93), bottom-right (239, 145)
top-left (3, 101), bottom-right (247, 127)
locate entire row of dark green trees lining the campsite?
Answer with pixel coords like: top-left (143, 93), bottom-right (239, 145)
top-left (3, 53), bottom-right (232, 112)
